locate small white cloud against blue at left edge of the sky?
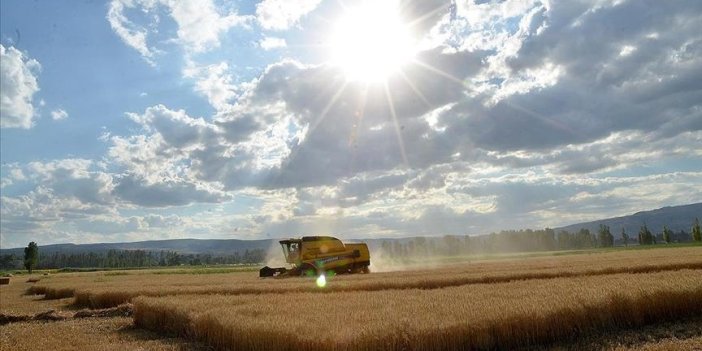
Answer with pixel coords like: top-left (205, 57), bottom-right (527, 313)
top-left (0, 44), bottom-right (41, 129)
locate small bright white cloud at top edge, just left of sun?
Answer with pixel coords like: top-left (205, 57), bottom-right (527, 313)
top-left (256, 0), bottom-right (321, 30)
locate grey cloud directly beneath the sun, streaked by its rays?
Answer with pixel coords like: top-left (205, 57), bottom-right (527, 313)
top-left (251, 50), bottom-right (490, 190)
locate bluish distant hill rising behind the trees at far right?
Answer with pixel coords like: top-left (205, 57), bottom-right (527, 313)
top-left (555, 202), bottom-right (702, 238)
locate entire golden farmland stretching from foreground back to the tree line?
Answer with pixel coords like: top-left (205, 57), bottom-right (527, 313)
top-left (0, 246), bottom-right (702, 350)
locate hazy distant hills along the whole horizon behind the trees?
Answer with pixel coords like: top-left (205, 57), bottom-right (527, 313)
top-left (0, 203), bottom-right (702, 257)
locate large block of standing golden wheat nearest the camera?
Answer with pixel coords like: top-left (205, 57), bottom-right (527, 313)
top-left (134, 270), bottom-right (702, 350)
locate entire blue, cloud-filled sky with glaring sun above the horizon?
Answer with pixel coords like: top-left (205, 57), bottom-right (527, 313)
top-left (0, 0), bottom-right (702, 248)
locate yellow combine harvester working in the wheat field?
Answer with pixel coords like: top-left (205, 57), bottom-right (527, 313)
top-left (259, 236), bottom-right (370, 277)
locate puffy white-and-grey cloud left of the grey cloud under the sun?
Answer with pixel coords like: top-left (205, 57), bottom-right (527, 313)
top-left (109, 105), bottom-right (302, 189)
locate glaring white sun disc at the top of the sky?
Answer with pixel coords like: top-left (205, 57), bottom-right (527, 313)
top-left (331, 1), bottom-right (415, 82)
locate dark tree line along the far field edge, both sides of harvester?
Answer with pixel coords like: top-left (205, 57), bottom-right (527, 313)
top-left (0, 218), bottom-right (702, 273)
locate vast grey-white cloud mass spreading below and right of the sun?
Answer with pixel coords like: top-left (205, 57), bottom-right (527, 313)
top-left (3, 0), bottom-right (702, 248)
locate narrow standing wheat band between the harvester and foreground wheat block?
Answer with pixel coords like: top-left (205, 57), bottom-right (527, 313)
top-left (62, 262), bottom-right (702, 308)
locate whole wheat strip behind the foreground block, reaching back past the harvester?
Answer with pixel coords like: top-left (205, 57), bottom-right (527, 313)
top-left (28, 247), bottom-right (702, 308)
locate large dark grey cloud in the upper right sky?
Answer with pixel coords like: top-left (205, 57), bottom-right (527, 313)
top-left (438, 2), bottom-right (702, 154)
